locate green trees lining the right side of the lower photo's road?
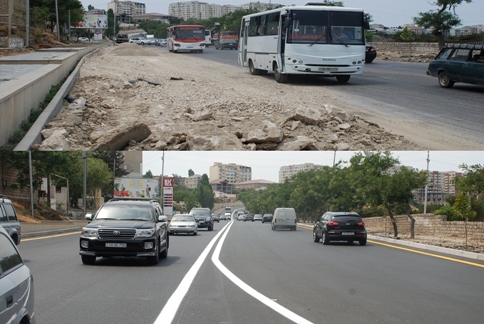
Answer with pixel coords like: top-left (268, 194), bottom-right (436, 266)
top-left (238, 152), bottom-right (484, 236)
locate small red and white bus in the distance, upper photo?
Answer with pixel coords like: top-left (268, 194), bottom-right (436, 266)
top-left (167, 25), bottom-right (205, 53)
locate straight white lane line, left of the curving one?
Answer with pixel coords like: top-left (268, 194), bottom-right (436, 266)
top-left (154, 219), bottom-right (231, 324)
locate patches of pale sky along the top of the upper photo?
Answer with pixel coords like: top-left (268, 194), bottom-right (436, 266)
top-left (81, 0), bottom-right (484, 27)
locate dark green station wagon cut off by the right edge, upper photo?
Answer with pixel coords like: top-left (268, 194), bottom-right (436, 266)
top-left (427, 44), bottom-right (484, 88)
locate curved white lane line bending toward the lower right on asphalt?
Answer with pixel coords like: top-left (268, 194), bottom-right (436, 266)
top-left (212, 223), bottom-right (312, 324)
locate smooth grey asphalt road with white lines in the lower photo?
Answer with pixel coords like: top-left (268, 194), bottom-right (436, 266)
top-left (19, 221), bottom-right (484, 324)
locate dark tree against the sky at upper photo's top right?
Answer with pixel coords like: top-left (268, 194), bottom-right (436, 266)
top-left (413, 0), bottom-right (472, 49)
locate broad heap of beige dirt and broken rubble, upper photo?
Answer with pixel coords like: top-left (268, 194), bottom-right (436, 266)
top-left (37, 43), bottom-right (419, 151)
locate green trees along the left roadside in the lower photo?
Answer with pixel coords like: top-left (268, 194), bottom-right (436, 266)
top-left (0, 149), bottom-right (128, 207)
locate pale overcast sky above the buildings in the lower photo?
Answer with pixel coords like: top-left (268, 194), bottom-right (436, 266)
top-left (142, 151), bottom-right (484, 182)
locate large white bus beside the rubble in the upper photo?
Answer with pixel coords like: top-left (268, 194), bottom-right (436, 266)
top-left (238, 4), bottom-right (369, 83)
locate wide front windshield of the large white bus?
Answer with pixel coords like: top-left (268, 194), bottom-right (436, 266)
top-left (287, 10), bottom-right (365, 45)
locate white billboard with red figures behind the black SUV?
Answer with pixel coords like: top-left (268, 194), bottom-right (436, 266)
top-left (114, 178), bottom-right (159, 198)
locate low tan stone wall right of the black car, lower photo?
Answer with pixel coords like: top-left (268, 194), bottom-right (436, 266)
top-left (363, 214), bottom-right (484, 241)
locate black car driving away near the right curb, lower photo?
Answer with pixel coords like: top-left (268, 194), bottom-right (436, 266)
top-left (313, 212), bottom-right (366, 245)
